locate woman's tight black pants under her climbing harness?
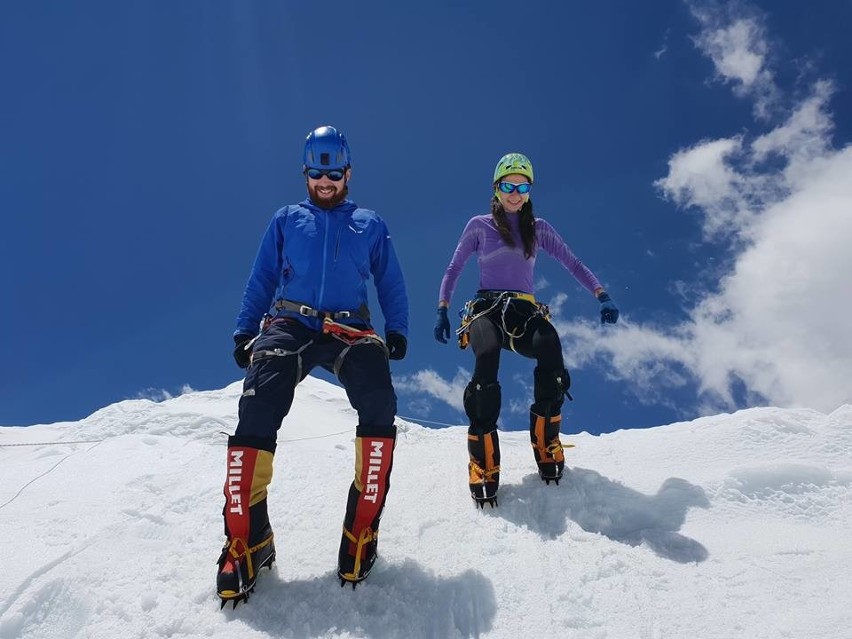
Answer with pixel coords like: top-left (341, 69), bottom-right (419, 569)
top-left (465, 299), bottom-right (567, 433)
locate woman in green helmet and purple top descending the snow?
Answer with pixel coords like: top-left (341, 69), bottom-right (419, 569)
top-left (435, 153), bottom-right (618, 507)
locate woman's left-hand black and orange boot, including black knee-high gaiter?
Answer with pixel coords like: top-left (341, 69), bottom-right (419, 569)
top-left (463, 378), bottom-right (501, 508)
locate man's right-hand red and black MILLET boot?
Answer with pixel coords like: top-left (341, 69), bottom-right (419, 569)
top-left (337, 425), bottom-right (396, 588)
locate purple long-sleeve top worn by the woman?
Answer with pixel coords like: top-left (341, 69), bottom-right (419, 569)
top-left (438, 214), bottom-right (601, 302)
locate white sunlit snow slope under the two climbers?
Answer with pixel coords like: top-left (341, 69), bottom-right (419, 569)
top-left (0, 377), bottom-right (852, 639)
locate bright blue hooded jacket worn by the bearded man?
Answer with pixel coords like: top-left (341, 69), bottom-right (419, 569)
top-left (234, 199), bottom-right (408, 336)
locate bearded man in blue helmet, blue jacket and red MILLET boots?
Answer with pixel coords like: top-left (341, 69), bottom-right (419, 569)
top-left (217, 126), bottom-right (408, 607)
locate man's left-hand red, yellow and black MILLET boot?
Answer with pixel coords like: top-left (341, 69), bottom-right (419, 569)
top-left (216, 436), bottom-right (275, 610)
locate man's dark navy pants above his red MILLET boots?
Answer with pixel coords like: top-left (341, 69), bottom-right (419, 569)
top-left (235, 320), bottom-right (396, 441)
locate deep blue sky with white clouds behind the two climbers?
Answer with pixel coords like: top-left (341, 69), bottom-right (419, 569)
top-left (0, 0), bottom-right (852, 433)
